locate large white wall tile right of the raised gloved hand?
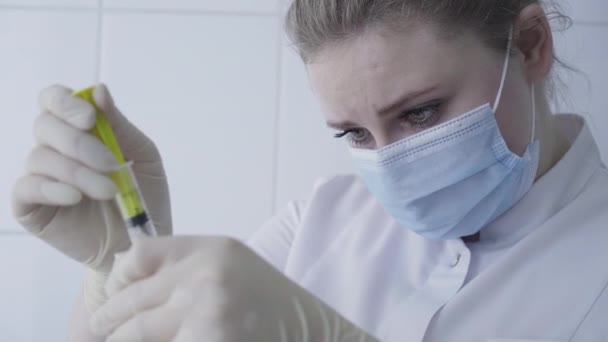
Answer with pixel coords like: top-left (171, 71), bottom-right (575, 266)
top-left (101, 13), bottom-right (279, 236)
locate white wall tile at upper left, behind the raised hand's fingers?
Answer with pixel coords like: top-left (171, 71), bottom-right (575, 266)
top-left (0, 10), bottom-right (97, 231)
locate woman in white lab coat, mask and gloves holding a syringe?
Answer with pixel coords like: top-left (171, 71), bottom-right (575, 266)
top-left (14, 0), bottom-right (608, 342)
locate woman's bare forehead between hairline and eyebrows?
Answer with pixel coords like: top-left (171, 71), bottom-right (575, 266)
top-left (307, 24), bottom-right (486, 113)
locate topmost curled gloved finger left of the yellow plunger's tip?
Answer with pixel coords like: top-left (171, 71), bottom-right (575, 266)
top-left (38, 85), bottom-right (95, 130)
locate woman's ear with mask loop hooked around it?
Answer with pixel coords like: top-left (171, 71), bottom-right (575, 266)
top-left (516, 4), bottom-right (554, 83)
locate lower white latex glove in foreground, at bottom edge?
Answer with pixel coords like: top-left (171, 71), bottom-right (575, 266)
top-left (91, 237), bottom-right (376, 342)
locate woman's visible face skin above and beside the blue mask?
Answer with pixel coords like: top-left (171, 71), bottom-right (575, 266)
top-left (307, 24), bottom-right (532, 155)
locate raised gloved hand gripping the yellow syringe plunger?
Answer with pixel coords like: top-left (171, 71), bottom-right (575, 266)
top-left (13, 85), bottom-right (172, 309)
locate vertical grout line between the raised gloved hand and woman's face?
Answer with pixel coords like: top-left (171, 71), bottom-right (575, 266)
top-left (271, 6), bottom-right (283, 215)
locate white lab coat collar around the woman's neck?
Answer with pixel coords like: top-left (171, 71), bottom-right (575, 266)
top-left (480, 114), bottom-right (601, 245)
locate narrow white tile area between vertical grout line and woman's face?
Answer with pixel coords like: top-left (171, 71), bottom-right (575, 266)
top-left (276, 41), bottom-right (354, 207)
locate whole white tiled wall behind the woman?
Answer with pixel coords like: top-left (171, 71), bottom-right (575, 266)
top-left (0, 0), bottom-right (608, 342)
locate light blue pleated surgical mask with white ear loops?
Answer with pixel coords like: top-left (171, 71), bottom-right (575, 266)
top-left (351, 29), bottom-right (539, 240)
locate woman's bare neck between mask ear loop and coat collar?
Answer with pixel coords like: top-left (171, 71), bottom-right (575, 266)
top-left (536, 92), bottom-right (570, 180)
